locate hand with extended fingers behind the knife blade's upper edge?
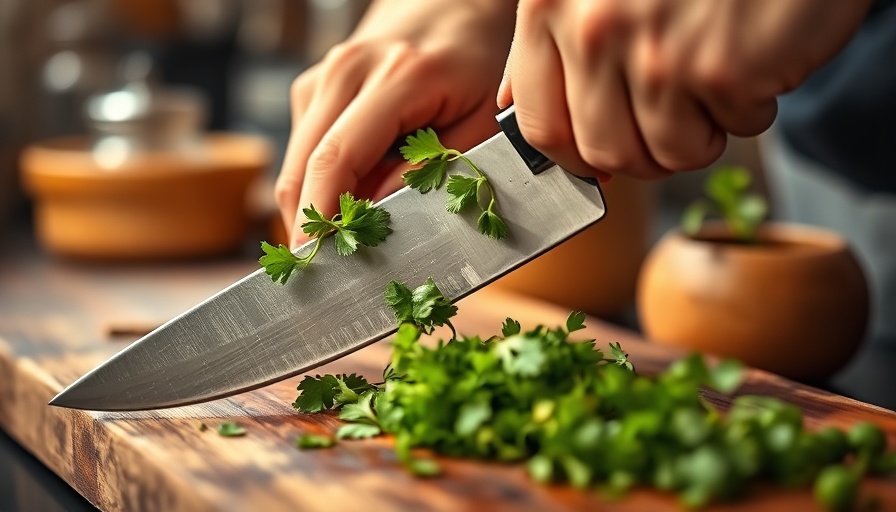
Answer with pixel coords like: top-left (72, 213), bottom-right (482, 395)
top-left (275, 0), bottom-right (516, 248)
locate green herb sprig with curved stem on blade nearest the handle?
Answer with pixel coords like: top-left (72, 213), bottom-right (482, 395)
top-left (399, 128), bottom-right (508, 239)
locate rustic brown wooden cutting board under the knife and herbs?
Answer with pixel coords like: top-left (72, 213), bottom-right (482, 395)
top-left (0, 244), bottom-right (896, 512)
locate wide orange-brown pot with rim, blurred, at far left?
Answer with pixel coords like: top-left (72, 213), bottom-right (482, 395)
top-left (21, 134), bottom-right (270, 259)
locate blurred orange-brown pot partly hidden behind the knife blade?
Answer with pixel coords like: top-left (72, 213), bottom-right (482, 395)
top-left (491, 176), bottom-right (653, 318)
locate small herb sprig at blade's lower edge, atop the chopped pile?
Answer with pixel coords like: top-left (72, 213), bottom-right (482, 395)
top-left (385, 277), bottom-right (457, 337)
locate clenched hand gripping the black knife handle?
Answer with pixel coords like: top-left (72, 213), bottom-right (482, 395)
top-left (498, 0), bottom-right (870, 182)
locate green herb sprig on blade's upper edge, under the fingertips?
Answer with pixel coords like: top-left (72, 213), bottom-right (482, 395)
top-left (258, 192), bottom-right (392, 284)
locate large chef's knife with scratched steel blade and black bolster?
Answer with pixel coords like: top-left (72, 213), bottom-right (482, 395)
top-left (50, 107), bottom-right (606, 411)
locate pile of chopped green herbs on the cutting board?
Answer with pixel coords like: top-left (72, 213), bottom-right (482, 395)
top-left (294, 280), bottom-right (896, 510)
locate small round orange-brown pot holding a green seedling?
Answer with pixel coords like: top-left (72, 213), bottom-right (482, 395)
top-left (637, 224), bottom-right (869, 381)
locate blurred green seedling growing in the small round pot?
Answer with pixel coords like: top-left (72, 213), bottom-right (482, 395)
top-left (681, 167), bottom-right (768, 242)
